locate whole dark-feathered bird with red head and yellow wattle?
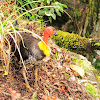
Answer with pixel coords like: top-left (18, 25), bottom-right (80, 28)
top-left (12, 22), bottom-right (58, 90)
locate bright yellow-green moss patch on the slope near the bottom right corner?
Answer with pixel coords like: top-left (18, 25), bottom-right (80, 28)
top-left (86, 82), bottom-right (98, 97)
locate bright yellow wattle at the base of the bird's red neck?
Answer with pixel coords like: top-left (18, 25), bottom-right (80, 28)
top-left (38, 41), bottom-right (50, 56)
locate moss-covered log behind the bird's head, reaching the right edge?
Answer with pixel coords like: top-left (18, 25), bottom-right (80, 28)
top-left (51, 30), bottom-right (100, 54)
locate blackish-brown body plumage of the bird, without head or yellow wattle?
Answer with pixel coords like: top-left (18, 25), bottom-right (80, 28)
top-left (15, 33), bottom-right (45, 63)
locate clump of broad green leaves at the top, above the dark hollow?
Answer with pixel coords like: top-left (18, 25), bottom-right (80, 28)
top-left (16, 0), bottom-right (67, 22)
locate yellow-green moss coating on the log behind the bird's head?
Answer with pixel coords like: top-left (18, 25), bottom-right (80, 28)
top-left (51, 30), bottom-right (87, 51)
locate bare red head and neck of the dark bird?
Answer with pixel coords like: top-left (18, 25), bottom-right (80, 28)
top-left (43, 26), bottom-right (58, 44)
